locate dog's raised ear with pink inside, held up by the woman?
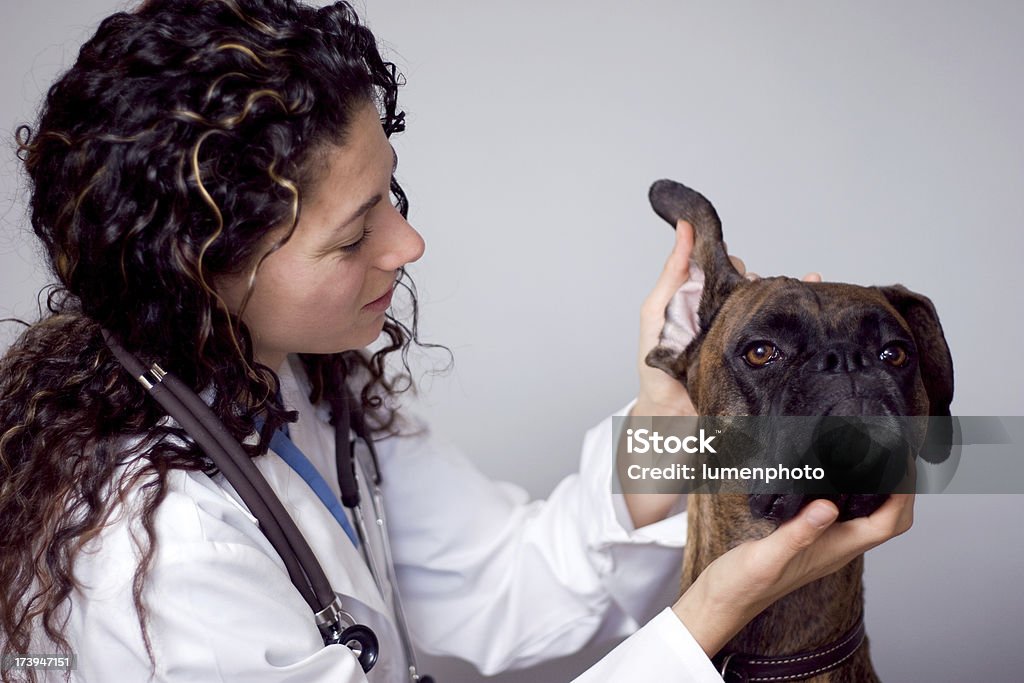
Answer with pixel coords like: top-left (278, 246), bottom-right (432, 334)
top-left (645, 180), bottom-right (743, 395)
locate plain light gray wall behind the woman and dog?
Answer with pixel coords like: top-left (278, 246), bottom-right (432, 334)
top-left (0, 0), bottom-right (1024, 682)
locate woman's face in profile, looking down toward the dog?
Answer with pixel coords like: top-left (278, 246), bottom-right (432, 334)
top-left (217, 103), bottom-right (424, 371)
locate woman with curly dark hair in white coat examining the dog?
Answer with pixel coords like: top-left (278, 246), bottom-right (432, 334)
top-left (0, 0), bottom-right (912, 681)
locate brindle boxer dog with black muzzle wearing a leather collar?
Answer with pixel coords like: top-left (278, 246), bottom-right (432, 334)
top-left (647, 180), bottom-right (953, 682)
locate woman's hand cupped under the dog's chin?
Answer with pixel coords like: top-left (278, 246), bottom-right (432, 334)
top-left (673, 494), bottom-right (913, 657)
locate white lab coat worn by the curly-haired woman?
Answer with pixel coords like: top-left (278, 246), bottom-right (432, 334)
top-left (49, 357), bottom-right (721, 683)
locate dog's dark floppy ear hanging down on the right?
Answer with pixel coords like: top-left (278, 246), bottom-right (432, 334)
top-left (878, 285), bottom-right (953, 463)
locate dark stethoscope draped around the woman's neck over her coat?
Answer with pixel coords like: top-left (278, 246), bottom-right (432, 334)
top-left (100, 328), bottom-right (433, 683)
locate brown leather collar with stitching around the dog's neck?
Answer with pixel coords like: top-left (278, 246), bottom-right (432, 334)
top-left (713, 615), bottom-right (864, 683)
